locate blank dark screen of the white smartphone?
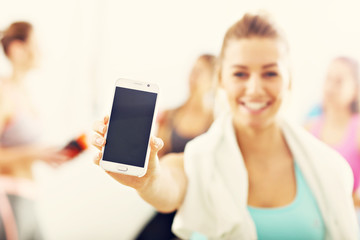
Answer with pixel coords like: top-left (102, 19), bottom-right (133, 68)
top-left (103, 87), bottom-right (157, 167)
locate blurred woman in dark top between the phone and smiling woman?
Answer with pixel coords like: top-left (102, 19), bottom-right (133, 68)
top-left (137, 54), bottom-right (216, 240)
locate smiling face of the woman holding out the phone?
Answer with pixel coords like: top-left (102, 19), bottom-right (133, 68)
top-left (220, 38), bottom-right (289, 128)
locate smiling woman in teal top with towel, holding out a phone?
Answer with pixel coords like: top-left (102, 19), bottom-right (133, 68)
top-left (93, 14), bottom-right (358, 240)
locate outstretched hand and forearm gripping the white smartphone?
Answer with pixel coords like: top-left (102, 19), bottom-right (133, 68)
top-left (93, 117), bottom-right (187, 213)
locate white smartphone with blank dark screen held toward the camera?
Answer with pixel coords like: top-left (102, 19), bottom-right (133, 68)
top-left (100, 79), bottom-right (159, 177)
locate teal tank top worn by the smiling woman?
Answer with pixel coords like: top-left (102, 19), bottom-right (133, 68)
top-left (248, 164), bottom-right (325, 240)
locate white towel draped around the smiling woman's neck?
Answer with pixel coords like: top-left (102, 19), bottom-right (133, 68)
top-left (172, 114), bottom-right (358, 240)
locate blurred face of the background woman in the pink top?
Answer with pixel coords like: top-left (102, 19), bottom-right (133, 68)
top-left (324, 60), bottom-right (357, 109)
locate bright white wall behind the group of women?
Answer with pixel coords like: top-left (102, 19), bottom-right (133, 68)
top-left (0, 0), bottom-right (360, 239)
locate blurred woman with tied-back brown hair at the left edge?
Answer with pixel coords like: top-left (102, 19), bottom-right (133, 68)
top-left (0, 22), bottom-right (68, 239)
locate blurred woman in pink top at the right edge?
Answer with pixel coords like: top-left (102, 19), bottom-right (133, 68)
top-left (306, 57), bottom-right (360, 207)
